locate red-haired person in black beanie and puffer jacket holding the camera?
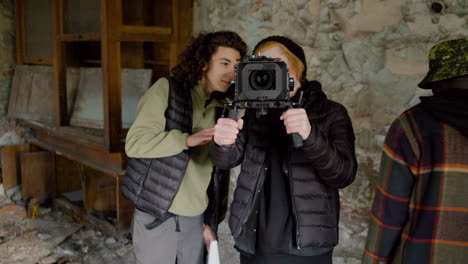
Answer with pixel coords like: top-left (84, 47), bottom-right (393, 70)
top-left (210, 36), bottom-right (357, 264)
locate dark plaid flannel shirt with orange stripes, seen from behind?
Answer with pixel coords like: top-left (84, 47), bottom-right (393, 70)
top-left (362, 106), bottom-right (468, 264)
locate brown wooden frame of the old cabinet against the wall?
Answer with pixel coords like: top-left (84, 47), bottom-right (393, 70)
top-left (15, 0), bottom-right (192, 152)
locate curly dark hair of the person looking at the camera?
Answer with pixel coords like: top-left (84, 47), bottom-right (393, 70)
top-left (172, 31), bottom-right (247, 87)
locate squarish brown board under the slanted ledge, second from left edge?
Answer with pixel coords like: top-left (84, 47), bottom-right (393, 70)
top-left (20, 151), bottom-right (56, 201)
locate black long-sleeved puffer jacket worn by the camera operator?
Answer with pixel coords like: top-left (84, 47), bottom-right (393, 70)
top-left (210, 81), bottom-right (357, 254)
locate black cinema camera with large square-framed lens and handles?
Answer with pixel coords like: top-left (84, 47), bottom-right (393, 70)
top-left (225, 55), bottom-right (303, 148)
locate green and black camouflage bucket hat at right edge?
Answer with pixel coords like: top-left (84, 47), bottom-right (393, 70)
top-left (418, 39), bottom-right (468, 89)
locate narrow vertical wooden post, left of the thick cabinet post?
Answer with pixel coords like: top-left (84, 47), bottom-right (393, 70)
top-left (51, 0), bottom-right (69, 127)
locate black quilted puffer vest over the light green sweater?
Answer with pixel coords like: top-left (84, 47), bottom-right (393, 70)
top-left (122, 78), bottom-right (229, 232)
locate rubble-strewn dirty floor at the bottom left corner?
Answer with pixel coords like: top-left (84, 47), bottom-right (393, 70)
top-left (0, 184), bottom-right (135, 264)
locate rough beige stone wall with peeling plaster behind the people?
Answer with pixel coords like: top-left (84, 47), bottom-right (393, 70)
top-left (194, 0), bottom-right (468, 263)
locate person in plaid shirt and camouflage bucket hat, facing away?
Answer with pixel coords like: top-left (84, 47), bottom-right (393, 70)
top-left (362, 39), bottom-right (468, 264)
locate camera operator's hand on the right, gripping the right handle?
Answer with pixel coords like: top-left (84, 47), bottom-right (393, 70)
top-left (280, 108), bottom-right (311, 140)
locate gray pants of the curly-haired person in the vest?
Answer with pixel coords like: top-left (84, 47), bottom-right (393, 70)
top-left (132, 209), bottom-right (204, 264)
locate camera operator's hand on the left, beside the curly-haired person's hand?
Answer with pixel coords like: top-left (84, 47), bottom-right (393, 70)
top-left (214, 118), bottom-right (244, 146)
